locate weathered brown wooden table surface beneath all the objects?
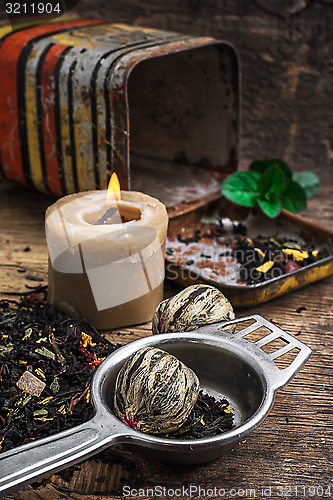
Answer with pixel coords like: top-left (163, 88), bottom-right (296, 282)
top-left (0, 179), bottom-right (333, 500)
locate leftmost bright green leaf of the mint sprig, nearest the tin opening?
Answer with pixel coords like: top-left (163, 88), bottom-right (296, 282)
top-left (221, 172), bottom-right (260, 207)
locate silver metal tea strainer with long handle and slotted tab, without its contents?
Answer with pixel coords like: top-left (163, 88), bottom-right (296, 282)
top-left (0, 315), bottom-right (311, 495)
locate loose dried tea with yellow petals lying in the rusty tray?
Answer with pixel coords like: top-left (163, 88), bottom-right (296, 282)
top-left (166, 223), bottom-right (332, 286)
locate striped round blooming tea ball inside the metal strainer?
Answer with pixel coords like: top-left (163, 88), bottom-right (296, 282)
top-left (114, 347), bottom-right (199, 434)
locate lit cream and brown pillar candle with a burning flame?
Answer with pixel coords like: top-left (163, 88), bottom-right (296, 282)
top-left (46, 174), bottom-right (168, 330)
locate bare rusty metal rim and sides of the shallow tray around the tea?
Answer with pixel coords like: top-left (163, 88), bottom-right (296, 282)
top-left (166, 203), bottom-right (333, 307)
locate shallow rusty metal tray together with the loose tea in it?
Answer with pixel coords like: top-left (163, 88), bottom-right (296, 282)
top-left (166, 200), bottom-right (333, 307)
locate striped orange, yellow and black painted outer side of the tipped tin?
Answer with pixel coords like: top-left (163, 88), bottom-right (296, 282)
top-left (0, 20), bottom-right (184, 196)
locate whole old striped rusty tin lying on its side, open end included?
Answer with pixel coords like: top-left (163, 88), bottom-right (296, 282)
top-left (0, 20), bottom-right (240, 213)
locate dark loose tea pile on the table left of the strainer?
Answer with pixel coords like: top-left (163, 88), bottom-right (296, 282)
top-left (0, 295), bottom-right (116, 451)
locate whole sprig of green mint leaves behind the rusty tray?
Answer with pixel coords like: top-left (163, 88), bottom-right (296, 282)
top-left (221, 158), bottom-right (319, 217)
